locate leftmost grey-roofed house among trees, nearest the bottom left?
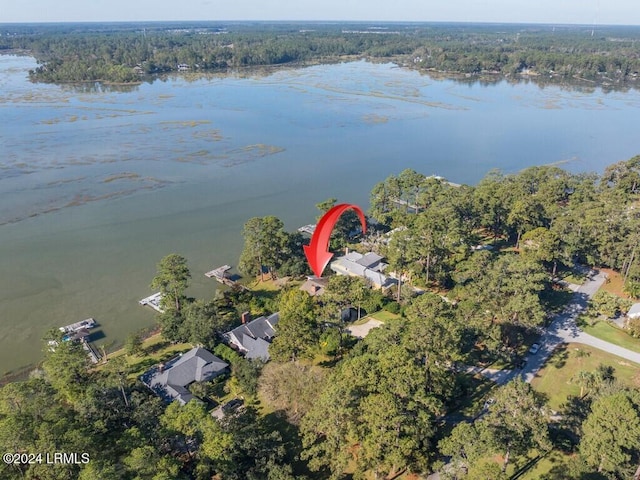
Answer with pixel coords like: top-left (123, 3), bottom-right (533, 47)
top-left (140, 347), bottom-right (229, 405)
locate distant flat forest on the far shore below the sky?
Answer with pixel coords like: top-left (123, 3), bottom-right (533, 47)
top-left (0, 22), bottom-right (640, 88)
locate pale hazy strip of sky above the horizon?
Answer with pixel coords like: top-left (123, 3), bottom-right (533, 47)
top-left (0, 0), bottom-right (640, 25)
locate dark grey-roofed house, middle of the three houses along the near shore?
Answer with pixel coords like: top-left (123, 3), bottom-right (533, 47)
top-left (224, 312), bottom-right (280, 361)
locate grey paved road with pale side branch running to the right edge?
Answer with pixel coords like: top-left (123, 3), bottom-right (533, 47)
top-left (481, 273), bottom-right (640, 385)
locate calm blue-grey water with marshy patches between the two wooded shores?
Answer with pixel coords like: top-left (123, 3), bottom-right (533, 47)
top-left (0, 56), bottom-right (640, 374)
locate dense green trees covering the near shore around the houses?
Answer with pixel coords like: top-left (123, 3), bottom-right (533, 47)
top-left (0, 157), bottom-right (640, 480)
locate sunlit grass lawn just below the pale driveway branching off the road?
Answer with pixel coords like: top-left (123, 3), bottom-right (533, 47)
top-left (531, 343), bottom-right (640, 411)
